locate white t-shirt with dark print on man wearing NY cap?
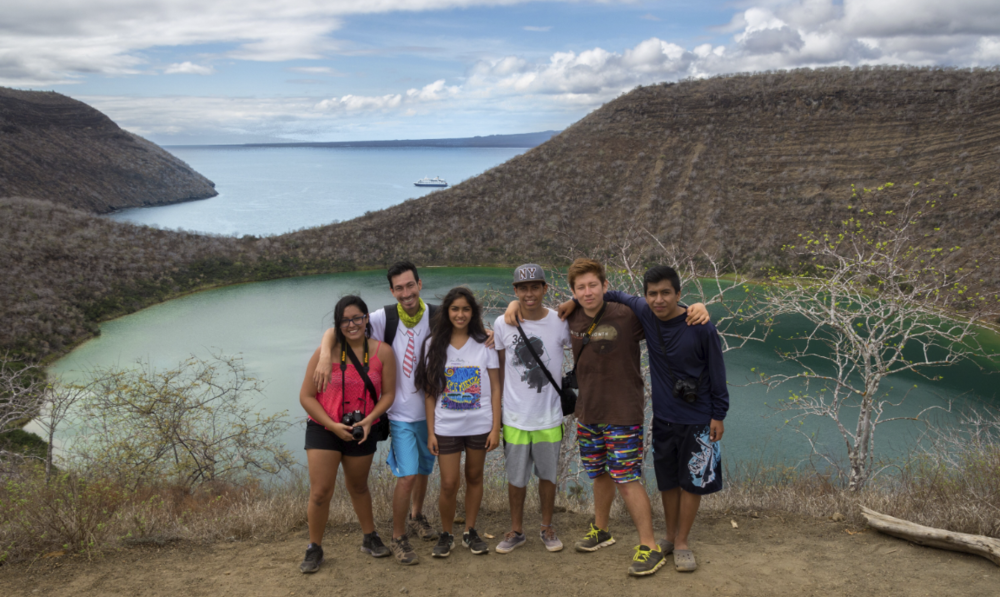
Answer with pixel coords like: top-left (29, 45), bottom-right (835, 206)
top-left (493, 309), bottom-right (570, 431)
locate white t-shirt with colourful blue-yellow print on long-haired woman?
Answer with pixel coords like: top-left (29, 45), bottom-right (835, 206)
top-left (427, 338), bottom-right (500, 436)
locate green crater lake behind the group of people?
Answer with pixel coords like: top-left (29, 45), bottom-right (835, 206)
top-left (50, 268), bottom-right (1000, 466)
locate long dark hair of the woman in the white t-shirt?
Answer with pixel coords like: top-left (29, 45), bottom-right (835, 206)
top-left (414, 286), bottom-right (486, 398)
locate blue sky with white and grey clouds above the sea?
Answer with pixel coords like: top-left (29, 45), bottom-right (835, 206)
top-left (0, 0), bottom-right (1000, 144)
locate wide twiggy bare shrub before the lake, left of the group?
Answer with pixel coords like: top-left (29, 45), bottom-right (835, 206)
top-left (71, 355), bottom-right (293, 487)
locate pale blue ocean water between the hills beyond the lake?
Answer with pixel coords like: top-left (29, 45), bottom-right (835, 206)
top-left (107, 147), bottom-right (527, 236)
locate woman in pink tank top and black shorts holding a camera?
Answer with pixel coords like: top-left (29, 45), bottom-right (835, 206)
top-left (299, 296), bottom-right (396, 573)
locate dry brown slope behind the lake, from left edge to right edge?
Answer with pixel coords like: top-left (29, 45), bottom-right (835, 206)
top-left (0, 68), bottom-right (1000, 359)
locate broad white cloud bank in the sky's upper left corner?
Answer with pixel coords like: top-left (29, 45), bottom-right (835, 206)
top-left (0, 0), bottom-right (564, 86)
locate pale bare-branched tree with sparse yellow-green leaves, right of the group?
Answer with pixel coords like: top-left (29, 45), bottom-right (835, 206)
top-left (757, 185), bottom-right (988, 491)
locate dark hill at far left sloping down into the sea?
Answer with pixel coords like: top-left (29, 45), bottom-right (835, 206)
top-left (0, 87), bottom-right (218, 213)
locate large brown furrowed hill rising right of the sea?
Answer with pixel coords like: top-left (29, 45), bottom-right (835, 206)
top-left (296, 68), bottom-right (1000, 282)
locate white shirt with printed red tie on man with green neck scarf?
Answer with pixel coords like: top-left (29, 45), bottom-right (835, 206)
top-left (368, 308), bottom-right (431, 423)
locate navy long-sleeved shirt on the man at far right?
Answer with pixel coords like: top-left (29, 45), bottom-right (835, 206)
top-left (604, 290), bottom-right (729, 425)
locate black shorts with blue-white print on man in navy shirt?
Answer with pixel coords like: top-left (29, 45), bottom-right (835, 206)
top-left (653, 417), bottom-right (722, 495)
